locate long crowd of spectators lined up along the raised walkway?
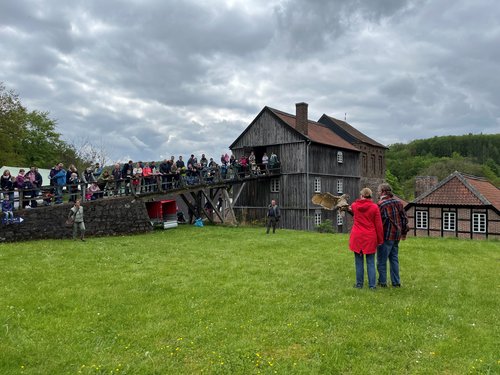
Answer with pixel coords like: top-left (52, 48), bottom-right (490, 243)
top-left (0, 151), bottom-right (280, 216)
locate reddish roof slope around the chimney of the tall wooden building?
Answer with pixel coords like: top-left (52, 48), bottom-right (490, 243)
top-left (266, 107), bottom-right (359, 152)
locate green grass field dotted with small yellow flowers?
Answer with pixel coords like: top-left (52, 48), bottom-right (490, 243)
top-left (0, 226), bottom-right (500, 374)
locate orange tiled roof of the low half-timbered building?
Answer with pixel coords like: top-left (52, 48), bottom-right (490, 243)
top-left (412, 172), bottom-right (500, 210)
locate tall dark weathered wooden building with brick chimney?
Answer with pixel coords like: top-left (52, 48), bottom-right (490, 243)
top-left (229, 103), bottom-right (384, 232)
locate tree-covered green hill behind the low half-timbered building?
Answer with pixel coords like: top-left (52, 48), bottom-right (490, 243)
top-left (386, 134), bottom-right (500, 200)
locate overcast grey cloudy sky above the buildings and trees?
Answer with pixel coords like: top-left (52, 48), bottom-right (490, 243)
top-left (0, 0), bottom-right (500, 161)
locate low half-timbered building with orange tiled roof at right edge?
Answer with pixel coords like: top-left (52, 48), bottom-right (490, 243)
top-left (405, 172), bottom-right (500, 239)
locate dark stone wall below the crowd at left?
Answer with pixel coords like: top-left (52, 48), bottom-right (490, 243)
top-left (0, 196), bottom-right (153, 242)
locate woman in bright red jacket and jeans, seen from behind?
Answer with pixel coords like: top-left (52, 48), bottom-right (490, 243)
top-left (349, 188), bottom-right (384, 289)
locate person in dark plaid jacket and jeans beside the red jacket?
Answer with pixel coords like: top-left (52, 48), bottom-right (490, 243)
top-left (377, 183), bottom-right (408, 288)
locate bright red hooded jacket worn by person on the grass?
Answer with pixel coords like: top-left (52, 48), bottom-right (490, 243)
top-left (349, 199), bottom-right (384, 254)
